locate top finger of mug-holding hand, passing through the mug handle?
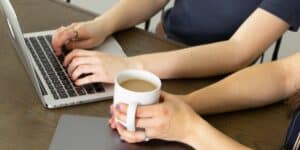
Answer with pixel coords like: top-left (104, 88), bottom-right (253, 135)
top-left (119, 104), bottom-right (161, 118)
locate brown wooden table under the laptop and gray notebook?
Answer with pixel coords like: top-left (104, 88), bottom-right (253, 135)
top-left (0, 0), bottom-right (288, 150)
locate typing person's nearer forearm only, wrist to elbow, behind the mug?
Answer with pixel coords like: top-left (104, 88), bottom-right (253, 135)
top-left (131, 40), bottom-right (252, 78)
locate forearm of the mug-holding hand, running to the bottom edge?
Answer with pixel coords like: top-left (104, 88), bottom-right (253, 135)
top-left (182, 118), bottom-right (250, 150)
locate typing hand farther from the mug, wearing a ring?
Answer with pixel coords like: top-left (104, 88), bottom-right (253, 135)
top-left (52, 21), bottom-right (111, 55)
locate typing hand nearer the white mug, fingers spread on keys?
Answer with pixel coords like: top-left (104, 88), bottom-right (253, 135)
top-left (63, 49), bottom-right (142, 86)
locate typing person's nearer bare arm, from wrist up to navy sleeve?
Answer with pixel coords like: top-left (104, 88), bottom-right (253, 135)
top-left (130, 8), bottom-right (288, 78)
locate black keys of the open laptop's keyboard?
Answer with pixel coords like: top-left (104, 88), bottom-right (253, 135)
top-left (25, 35), bottom-right (104, 100)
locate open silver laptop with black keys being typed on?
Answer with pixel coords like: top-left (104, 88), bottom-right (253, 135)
top-left (0, 0), bottom-right (126, 108)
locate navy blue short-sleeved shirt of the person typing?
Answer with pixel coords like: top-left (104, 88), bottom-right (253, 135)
top-left (163, 0), bottom-right (300, 45)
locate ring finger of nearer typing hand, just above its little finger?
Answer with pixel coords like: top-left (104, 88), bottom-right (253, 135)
top-left (71, 65), bottom-right (96, 81)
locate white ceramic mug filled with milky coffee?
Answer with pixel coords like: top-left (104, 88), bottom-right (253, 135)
top-left (113, 70), bottom-right (161, 131)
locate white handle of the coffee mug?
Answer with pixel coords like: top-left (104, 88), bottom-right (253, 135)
top-left (126, 103), bottom-right (137, 131)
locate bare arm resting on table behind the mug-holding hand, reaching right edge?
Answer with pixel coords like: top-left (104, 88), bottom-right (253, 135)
top-left (185, 53), bottom-right (300, 114)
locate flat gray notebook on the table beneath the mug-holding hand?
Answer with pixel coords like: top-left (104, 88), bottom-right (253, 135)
top-left (49, 115), bottom-right (192, 150)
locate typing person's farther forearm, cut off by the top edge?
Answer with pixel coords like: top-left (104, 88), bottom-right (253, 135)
top-left (95, 0), bottom-right (168, 34)
